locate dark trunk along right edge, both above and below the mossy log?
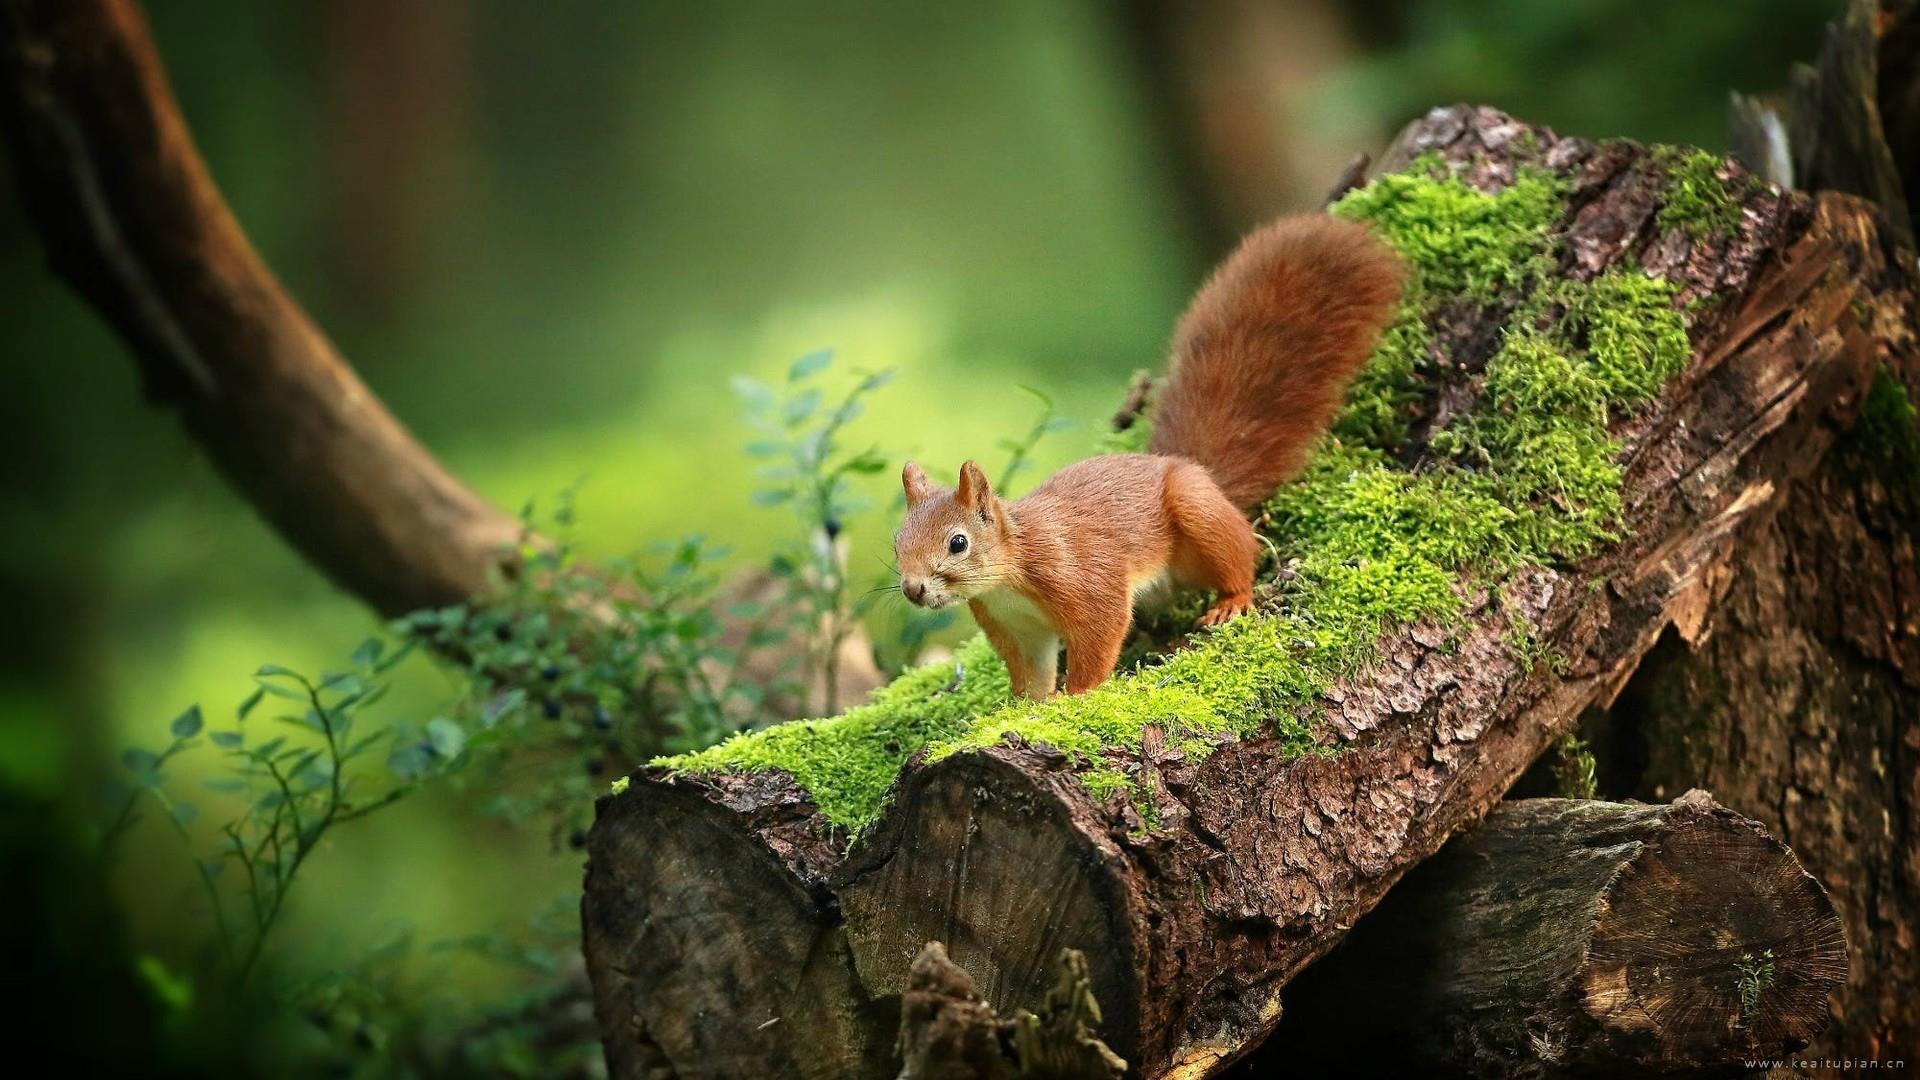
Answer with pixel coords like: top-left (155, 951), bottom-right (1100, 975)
top-left (1628, 0), bottom-right (1920, 1059)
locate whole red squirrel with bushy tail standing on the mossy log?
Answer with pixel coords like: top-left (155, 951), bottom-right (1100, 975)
top-left (893, 215), bottom-right (1405, 698)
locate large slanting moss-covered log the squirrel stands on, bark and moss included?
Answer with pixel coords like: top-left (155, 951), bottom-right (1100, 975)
top-left (582, 108), bottom-right (1901, 1076)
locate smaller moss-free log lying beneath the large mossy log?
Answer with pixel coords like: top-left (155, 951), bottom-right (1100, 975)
top-left (1248, 790), bottom-right (1847, 1076)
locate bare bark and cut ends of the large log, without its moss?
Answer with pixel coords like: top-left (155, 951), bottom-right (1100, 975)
top-left (584, 108), bottom-right (1912, 1076)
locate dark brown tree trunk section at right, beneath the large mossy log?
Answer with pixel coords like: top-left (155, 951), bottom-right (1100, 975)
top-left (1588, 340), bottom-right (1920, 1059)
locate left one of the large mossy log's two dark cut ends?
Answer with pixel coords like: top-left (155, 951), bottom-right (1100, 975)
top-left (580, 776), bottom-right (895, 1080)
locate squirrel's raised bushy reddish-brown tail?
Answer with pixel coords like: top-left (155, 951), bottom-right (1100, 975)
top-left (1148, 213), bottom-right (1405, 509)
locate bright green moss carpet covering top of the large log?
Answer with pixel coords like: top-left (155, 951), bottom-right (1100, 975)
top-left (664, 147), bottom-right (1712, 830)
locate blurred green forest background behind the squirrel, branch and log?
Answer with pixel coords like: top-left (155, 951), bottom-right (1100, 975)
top-left (0, 0), bottom-right (1837, 1068)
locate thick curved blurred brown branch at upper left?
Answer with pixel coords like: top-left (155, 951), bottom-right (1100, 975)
top-left (0, 0), bottom-right (520, 615)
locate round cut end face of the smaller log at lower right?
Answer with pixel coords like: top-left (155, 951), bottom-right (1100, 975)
top-left (1580, 795), bottom-right (1847, 1068)
